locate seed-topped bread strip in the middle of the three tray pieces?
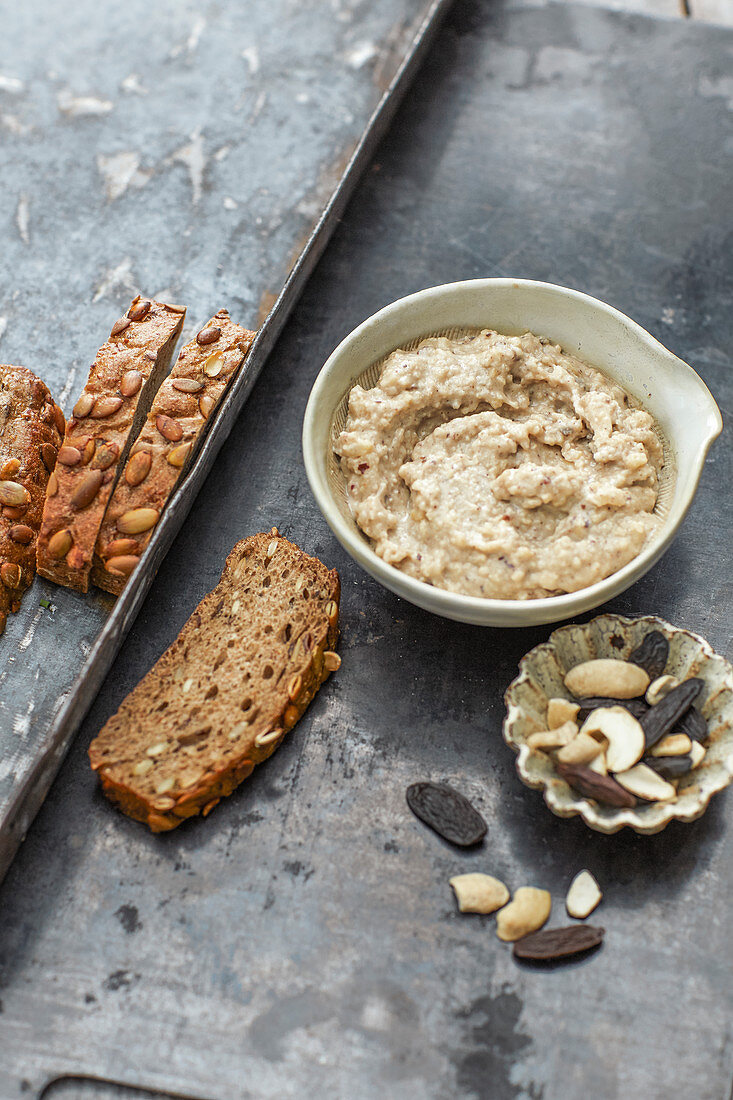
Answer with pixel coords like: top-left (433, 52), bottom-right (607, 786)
top-left (36, 296), bottom-right (186, 592)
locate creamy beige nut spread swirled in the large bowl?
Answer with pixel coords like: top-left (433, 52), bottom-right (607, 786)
top-left (336, 330), bottom-right (661, 600)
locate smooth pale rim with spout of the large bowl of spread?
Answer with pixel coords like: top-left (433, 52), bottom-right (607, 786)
top-left (302, 277), bottom-right (723, 625)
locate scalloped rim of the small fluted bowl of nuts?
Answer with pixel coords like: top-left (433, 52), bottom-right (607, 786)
top-left (502, 612), bottom-right (733, 836)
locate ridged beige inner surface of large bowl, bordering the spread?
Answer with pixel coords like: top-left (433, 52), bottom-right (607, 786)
top-left (328, 328), bottom-right (676, 528)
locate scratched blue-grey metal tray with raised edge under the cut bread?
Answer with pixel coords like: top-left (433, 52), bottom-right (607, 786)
top-left (0, 0), bottom-right (447, 878)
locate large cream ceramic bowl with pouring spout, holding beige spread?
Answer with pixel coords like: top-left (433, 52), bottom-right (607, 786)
top-left (303, 278), bottom-right (722, 627)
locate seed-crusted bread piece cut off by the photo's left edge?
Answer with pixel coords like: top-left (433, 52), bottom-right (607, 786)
top-left (0, 364), bottom-right (65, 634)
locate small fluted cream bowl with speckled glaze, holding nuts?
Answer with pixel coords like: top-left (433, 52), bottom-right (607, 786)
top-left (503, 615), bottom-right (733, 834)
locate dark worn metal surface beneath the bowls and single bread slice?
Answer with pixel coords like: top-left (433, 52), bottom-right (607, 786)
top-left (0, 0), bottom-right (733, 1100)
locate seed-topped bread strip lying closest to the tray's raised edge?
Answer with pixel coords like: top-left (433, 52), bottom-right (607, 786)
top-left (91, 309), bottom-right (255, 595)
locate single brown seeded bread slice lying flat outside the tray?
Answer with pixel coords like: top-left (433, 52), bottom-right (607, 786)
top-left (89, 528), bottom-right (341, 833)
